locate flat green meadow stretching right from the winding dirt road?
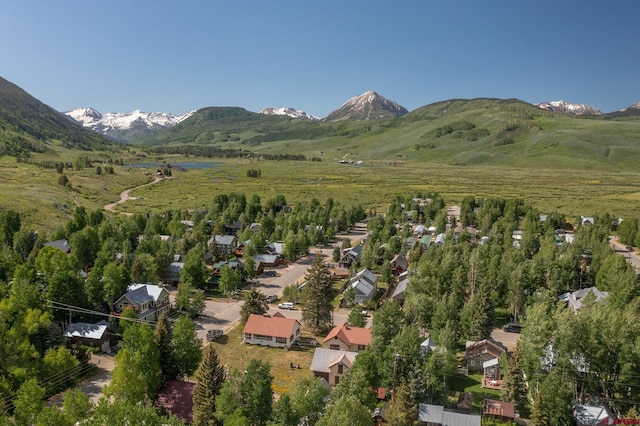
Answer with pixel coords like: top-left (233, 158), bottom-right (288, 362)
top-left (111, 158), bottom-right (640, 221)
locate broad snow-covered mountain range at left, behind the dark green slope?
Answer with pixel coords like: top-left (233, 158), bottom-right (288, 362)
top-left (65, 108), bottom-right (195, 140)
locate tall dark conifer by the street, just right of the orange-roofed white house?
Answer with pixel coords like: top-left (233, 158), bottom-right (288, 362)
top-left (301, 256), bottom-right (334, 332)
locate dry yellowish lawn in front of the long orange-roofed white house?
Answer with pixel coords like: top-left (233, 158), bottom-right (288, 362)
top-left (212, 327), bottom-right (322, 394)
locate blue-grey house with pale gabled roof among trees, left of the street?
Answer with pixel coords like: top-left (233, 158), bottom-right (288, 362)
top-left (114, 283), bottom-right (171, 322)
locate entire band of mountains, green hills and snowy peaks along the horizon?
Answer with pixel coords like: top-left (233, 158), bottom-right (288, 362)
top-left (0, 74), bottom-right (640, 170)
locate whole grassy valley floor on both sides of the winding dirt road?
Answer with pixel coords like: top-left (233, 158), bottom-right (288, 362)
top-left (0, 150), bottom-right (640, 230)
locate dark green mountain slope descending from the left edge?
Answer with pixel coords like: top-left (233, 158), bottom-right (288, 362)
top-left (0, 77), bottom-right (120, 156)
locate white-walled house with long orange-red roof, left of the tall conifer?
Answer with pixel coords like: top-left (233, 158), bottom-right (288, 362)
top-left (242, 313), bottom-right (301, 349)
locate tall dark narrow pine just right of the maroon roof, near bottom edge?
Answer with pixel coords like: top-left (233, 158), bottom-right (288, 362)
top-left (193, 344), bottom-right (224, 426)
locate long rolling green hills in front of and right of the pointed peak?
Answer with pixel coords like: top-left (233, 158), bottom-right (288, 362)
top-left (140, 99), bottom-right (640, 169)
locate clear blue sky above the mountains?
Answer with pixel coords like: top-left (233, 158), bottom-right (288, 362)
top-left (0, 0), bottom-right (640, 117)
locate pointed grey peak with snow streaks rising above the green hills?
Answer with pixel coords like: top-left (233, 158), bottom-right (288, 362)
top-left (324, 90), bottom-right (409, 121)
